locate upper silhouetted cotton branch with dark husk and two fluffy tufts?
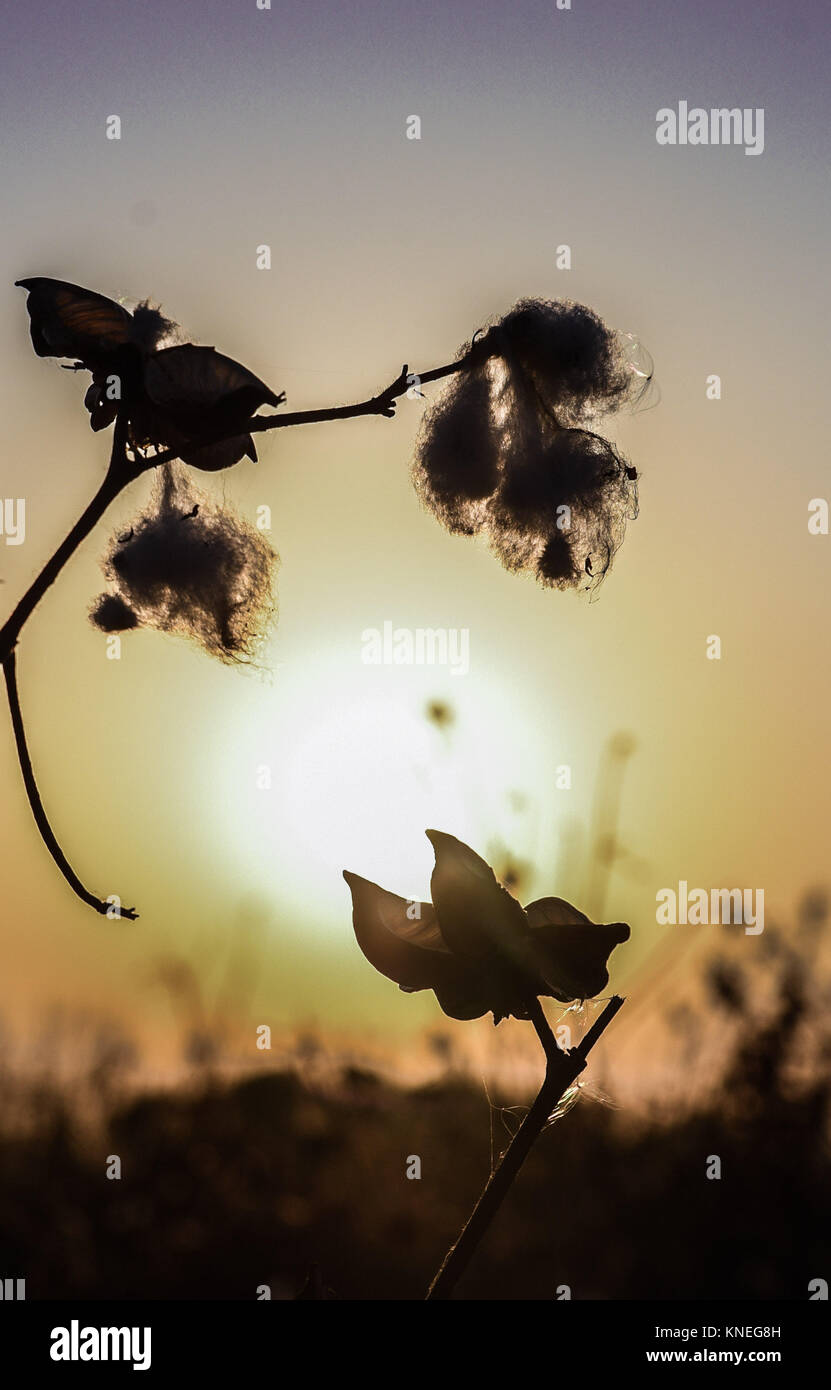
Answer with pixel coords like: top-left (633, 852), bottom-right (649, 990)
top-left (0, 277), bottom-right (652, 919)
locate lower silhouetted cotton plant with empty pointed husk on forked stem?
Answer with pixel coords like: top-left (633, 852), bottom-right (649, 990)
top-left (343, 830), bottom-right (630, 1300)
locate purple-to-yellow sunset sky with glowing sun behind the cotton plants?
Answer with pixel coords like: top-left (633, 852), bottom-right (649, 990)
top-left (0, 0), bottom-right (831, 1033)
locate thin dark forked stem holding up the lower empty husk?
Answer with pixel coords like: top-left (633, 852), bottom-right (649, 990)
top-left (427, 994), bottom-right (624, 1300)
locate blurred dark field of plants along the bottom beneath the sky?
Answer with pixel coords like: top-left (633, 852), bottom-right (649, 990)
top-left (0, 891), bottom-right (831, 1300)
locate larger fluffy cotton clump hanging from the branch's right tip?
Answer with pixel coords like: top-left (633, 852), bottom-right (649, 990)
top-left (414, 300), bottom-right (648, 589)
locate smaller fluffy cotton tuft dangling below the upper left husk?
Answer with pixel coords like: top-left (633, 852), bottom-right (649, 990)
top-left (90, 464), bottom-right (278, 663)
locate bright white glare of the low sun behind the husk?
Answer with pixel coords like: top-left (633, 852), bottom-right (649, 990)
top-left (224, 655), bottom-right (549, 923)
